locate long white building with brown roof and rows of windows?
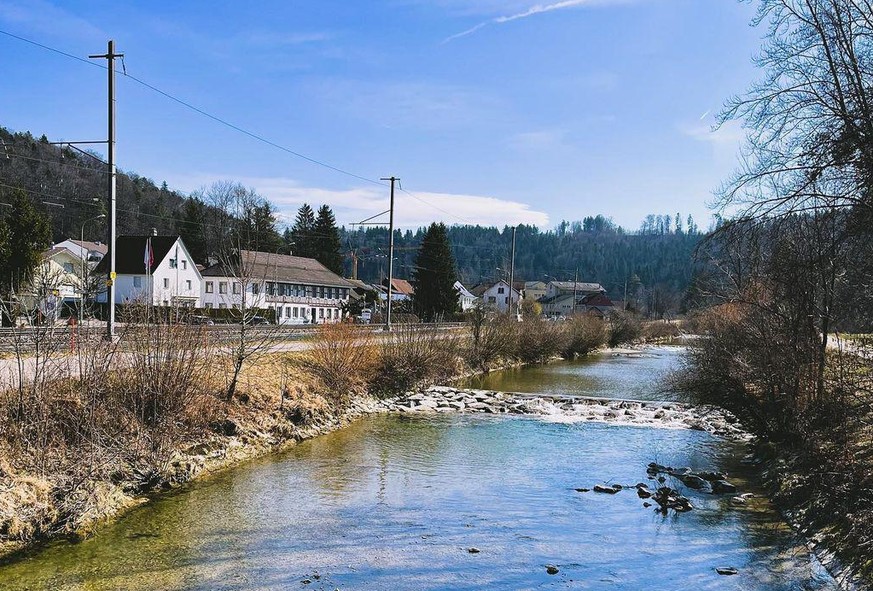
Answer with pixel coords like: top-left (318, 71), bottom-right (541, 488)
top-left (201, 250), bottom-right (353, 324)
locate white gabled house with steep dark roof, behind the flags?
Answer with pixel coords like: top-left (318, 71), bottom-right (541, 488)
top-left (95, 236), bottom-right (203, 308)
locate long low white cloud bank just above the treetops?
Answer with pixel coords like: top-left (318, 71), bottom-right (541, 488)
top-left (167, 174), bottom-right (549, 228)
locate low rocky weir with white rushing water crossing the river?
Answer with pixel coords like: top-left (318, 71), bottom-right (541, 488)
top-left (378, 386), bottom-right (749, 439)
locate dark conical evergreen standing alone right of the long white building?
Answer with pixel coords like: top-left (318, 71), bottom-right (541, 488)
top-left (412, 224), bottom-right (458, 322)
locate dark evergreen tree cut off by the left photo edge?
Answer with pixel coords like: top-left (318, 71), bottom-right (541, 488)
top-left (0, 189), bottom-right (52, 292)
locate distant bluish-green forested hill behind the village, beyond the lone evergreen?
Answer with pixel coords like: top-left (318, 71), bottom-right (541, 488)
top-left (342, 222), bottom-right (701, 300)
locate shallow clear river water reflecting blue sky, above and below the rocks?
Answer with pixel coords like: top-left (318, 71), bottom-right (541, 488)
top-left (0, 353), bottom-right (836, 591)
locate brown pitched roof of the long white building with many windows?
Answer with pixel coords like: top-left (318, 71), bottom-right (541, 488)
top-left (202, 250), bottom-right (353, 287)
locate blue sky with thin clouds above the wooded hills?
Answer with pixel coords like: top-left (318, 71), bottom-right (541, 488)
top-left (0, 0), bottom-right (763, 230)
